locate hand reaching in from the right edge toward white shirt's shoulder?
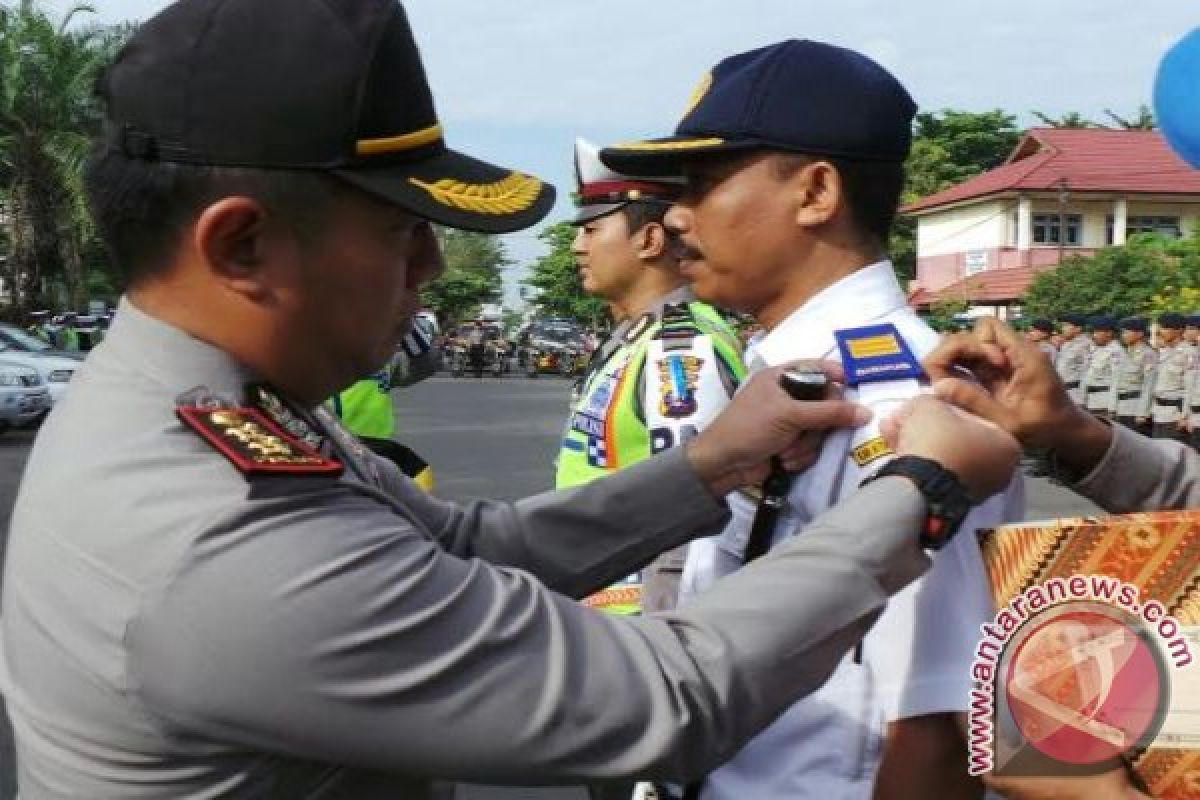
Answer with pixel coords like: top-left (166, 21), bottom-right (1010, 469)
top-left (924, 319), bottom-right (1112, 470)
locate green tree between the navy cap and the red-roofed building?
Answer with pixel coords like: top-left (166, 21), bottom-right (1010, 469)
top-left (888, 109), bottom-right (1021, 278)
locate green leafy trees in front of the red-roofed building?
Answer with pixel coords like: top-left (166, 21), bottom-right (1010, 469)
top-left (1025, 234), bottom-right (1200, 317)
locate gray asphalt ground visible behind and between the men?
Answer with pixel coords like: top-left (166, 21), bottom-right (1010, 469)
top-left (0, 377), bottom-right (1094, 800)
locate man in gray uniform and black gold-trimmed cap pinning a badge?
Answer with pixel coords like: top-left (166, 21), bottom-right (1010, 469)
top-left (0, 0), bottom-right (1016, 800)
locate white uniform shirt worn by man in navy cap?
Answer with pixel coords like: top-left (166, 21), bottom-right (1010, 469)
top-left (682, 261), bottom-right (1024, 800)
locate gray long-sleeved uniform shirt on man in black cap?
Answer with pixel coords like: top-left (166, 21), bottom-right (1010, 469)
top-left (0, 302), bottom-right (928, 800)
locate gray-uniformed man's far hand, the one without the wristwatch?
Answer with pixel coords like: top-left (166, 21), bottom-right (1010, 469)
top-left (686, 361), bottom-right (871, 495)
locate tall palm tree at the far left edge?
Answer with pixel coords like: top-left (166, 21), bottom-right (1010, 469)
top-left (0, 0), bottom-right (108, 313)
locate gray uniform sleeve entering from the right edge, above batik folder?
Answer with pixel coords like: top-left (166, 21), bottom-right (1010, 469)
top-left (1074, 425), bottom-right (1200, 513)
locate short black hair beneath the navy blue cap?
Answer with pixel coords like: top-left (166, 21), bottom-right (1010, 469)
top-left (774, 152), bottom-right (905, 246)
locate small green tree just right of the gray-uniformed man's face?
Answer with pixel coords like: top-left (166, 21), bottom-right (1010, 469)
top-left (425, 228), bottom-right (512, 329)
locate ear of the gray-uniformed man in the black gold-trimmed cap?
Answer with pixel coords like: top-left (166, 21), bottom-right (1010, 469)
top-left (192, 197), bottom-right (269, 300)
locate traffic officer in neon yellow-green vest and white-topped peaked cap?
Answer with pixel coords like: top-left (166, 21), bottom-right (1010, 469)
top-left (556, 139), bottom-right (744, 614)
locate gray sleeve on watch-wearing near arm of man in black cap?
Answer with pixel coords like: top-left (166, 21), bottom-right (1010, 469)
top-left (126, 479), bottom-right (928, 784)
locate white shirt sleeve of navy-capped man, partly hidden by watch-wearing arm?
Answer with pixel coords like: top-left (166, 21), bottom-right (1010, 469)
top-left (841, 380), bottom-right (1025, 718)
